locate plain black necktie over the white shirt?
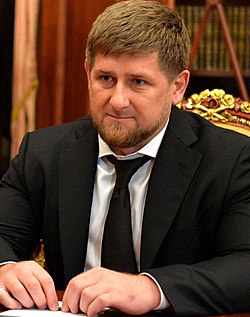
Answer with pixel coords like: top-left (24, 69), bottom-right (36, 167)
top-left (101, 156), bottom-right (150, 274)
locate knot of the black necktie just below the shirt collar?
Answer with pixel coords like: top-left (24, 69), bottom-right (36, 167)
top-left (107, 155), bottom-right (150, 188)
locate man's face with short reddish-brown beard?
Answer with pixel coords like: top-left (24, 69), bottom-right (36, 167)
top-left (85, 53), bottom-right (185, 155)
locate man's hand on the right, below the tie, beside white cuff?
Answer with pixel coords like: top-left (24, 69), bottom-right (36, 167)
top-left (62, 267), bottom-right (160, 316)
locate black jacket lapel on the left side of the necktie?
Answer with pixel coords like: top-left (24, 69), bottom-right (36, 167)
top-left (58, 124), bottom-right (98, 281)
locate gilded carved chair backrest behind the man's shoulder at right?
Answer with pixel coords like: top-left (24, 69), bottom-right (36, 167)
top-left (177, 89), bottom-right (250, 136)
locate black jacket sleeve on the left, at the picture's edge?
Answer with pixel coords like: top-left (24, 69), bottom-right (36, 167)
top-left (0, 134), bottom-right (39, 262)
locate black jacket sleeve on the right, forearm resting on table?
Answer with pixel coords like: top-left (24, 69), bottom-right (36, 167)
top-left (148, 142), bottom-right (250, 315)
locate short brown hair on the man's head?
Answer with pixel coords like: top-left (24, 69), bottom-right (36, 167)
top-left (86, 0), bottom-right (190, 80)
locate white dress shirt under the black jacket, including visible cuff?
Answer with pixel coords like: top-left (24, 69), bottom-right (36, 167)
top-left (85, 124), bottom-right (167, 309)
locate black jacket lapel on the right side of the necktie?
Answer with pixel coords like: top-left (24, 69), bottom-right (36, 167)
top-left (141, 107), bottom-right (202, 269)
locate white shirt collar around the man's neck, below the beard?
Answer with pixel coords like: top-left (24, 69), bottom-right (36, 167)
top-left (98, 121), bottom-right (168, 159)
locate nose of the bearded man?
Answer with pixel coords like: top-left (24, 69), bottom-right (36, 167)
top-left (110, 83), bottom-right (130, 110)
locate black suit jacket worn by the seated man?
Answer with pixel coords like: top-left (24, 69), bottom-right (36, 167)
top-left (0, 107), bottom-right (250, 315)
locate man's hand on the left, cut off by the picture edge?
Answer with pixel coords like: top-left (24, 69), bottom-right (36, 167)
top-left (0, 261), bottom-right (58, 310)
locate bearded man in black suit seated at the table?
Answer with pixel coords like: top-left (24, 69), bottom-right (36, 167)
top-left (0, 0), bottom-right (250, 316)
